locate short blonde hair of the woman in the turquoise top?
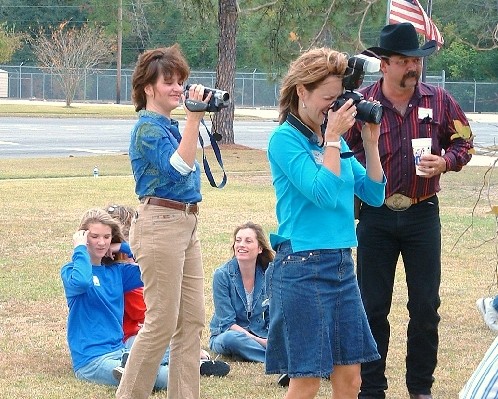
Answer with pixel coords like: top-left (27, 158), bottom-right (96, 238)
top-left (279, 47), bottom-right (347, 124)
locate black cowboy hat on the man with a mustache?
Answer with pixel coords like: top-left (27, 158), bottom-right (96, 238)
top-left (363, 22), bottom-right (437, 58)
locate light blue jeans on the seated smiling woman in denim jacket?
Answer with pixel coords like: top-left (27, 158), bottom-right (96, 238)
top-left (209, 330), bottom-right (266, 363)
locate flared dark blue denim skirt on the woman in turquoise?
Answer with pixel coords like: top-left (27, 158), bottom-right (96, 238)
top-left (265, 241), bottom-right (380, 378)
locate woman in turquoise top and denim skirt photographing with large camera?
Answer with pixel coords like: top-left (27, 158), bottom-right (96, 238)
top-left (266, 48), bottom-right (386, 399)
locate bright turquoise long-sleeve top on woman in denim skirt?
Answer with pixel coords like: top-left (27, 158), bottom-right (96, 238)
top-left (268, 122), bottom-right (386, 252)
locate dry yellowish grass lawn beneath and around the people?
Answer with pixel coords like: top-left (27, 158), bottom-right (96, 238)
top-left (0, 152), bottom-right (498, 399)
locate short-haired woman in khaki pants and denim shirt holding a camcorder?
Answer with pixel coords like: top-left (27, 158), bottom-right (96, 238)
top-left (116, 45), bottom-right (210, 399)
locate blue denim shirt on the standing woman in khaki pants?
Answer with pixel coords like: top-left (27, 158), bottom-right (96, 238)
top-left (129, 110), bottom-right (202, 203)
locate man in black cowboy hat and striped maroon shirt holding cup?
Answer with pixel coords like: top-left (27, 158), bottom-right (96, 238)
top-left (346, 23), bottom-right (472, 399)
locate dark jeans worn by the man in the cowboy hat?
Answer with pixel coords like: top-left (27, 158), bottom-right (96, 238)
top-left (356, 196), bottom-right (441, 398)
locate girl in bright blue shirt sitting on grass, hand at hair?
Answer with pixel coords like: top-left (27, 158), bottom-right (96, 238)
top-left (61, 209), bottom-right (168, 389)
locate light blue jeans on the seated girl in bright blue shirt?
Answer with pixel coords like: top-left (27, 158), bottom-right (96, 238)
top-left (75, 350), bottom-right (168, 390)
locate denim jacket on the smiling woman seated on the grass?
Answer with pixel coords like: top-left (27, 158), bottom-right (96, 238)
top-left (209, 258), bottom-right (270, 338)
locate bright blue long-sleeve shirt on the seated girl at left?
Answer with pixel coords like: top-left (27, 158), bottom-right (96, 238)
top-left (61, 245), bottom-right (143, 371)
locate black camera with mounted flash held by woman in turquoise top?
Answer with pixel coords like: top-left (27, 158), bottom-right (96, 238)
top-left (331, 54), bottom-right (382, 124)
